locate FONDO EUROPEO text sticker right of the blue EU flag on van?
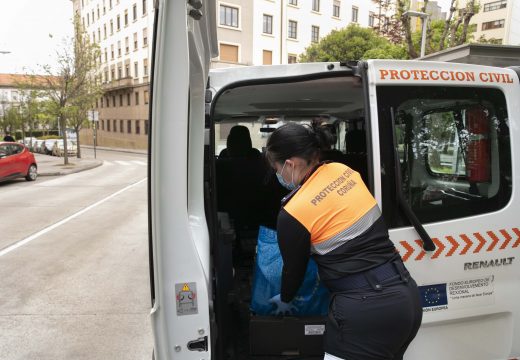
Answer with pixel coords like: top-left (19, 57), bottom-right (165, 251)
top-left (448, 275), bottom-right (495, 309)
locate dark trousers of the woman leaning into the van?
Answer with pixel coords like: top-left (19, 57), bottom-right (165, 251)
top-left (324, 264), bottom-right (422, 360)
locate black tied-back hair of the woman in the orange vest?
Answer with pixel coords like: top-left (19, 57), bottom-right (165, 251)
top-left (267, 123), bottom-right (330, 163)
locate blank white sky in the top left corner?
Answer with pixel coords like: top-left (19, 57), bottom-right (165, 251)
top-left (0, 0), bottom-right (73, 74)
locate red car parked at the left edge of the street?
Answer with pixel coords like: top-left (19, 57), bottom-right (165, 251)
top-left (0, 142), bottom-right (38, 181)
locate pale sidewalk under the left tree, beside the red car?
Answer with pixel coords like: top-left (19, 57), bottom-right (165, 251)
top-left (34, 154), bottom-right (103, 176)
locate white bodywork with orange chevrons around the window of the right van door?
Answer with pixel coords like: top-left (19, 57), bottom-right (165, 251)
top-left (368, 60), bottom-right (520, 360)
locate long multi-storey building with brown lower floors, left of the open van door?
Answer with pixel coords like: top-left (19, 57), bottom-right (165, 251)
top-left (73, 0), bottom-right (153, 149)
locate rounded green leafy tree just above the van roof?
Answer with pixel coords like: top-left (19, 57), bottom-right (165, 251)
top-left (300, 24), bottom-right (406, 62)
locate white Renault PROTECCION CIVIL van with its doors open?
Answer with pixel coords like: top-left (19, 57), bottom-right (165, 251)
top-left (146, 0), bottom-right (520, 360)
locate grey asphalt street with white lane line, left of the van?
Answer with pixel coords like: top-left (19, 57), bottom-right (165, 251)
top-left (0, 149), bottom-right (153, 360)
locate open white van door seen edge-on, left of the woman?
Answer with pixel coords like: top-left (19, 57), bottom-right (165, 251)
top-left (149, 0), bottom-right (217, 360)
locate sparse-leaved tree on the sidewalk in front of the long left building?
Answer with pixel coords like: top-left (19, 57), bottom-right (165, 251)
top-left (39, 15), bottom-right (100, 165)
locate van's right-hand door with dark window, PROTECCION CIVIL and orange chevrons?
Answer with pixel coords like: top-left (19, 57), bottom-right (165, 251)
top-left (368, 61), bottom-right (520, 360)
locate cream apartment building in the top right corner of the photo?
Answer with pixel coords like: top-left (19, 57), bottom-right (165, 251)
top-left (470, 0), bottom-right (520, 45)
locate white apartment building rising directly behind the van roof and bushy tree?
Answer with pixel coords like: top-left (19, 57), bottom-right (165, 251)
top-left (212, 0), bottom-right (376, 68)
